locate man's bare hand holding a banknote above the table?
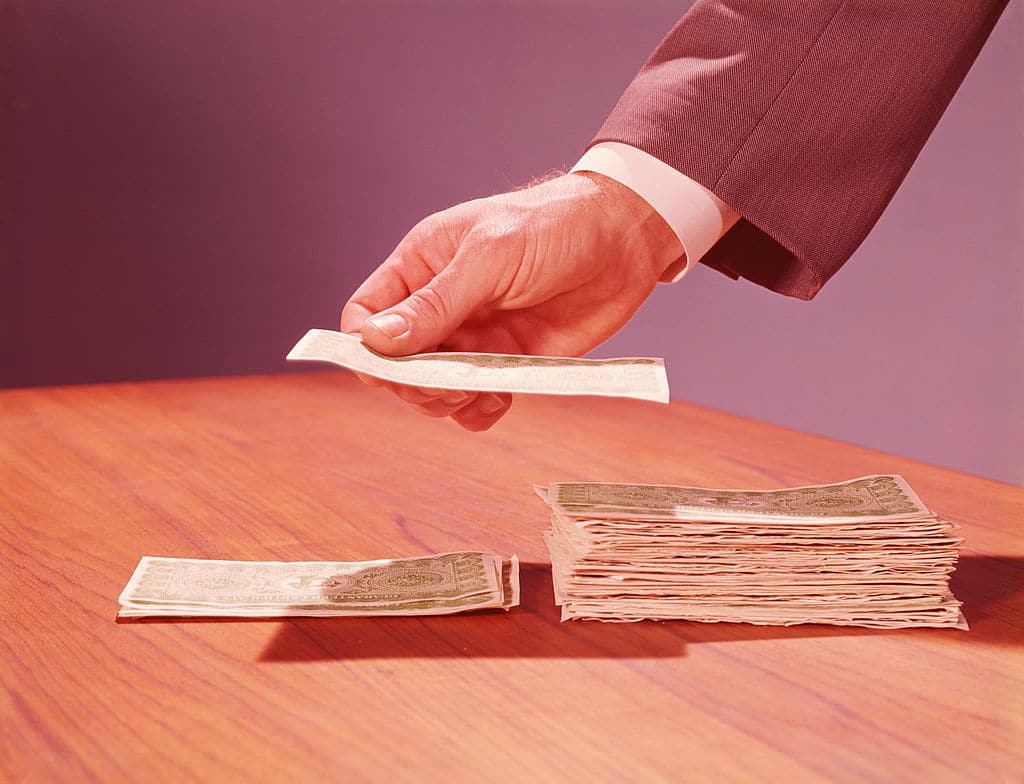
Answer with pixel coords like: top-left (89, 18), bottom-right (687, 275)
top-left (341, 172), bottom-right (683, 430)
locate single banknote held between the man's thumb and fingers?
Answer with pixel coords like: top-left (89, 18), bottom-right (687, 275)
top-left (288, 330), bottom-right (669, 403)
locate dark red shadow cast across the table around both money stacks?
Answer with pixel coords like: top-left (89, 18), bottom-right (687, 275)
top-left (260, 556), bottom-right (1024, 662)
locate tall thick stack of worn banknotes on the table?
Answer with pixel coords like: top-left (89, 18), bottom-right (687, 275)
top-left (536, 476), bottom-right (967, 628)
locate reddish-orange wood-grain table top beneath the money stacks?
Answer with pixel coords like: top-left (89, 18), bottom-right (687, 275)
top-left (0, 373), bottom-right (1024, 784)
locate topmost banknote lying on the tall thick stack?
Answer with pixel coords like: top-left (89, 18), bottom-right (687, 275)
top-left (539, 475), bottom-right (933, 523)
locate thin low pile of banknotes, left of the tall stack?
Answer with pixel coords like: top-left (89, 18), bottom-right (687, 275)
top-left (118, 552), bottom-right (519, 617)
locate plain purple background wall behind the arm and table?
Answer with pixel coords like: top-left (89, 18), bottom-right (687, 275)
top-left (0, 0), bottom-right (1024, 483)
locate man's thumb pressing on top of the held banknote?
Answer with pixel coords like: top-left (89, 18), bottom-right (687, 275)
top-left (361, 260), bottom-right (489, 356)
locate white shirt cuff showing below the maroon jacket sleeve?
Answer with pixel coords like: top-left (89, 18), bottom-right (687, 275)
top-left (570, 141), bottom-right (739, 284)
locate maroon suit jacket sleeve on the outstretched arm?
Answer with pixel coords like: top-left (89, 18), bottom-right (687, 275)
top-left (592, 0), bottom-right (1007, 299)
